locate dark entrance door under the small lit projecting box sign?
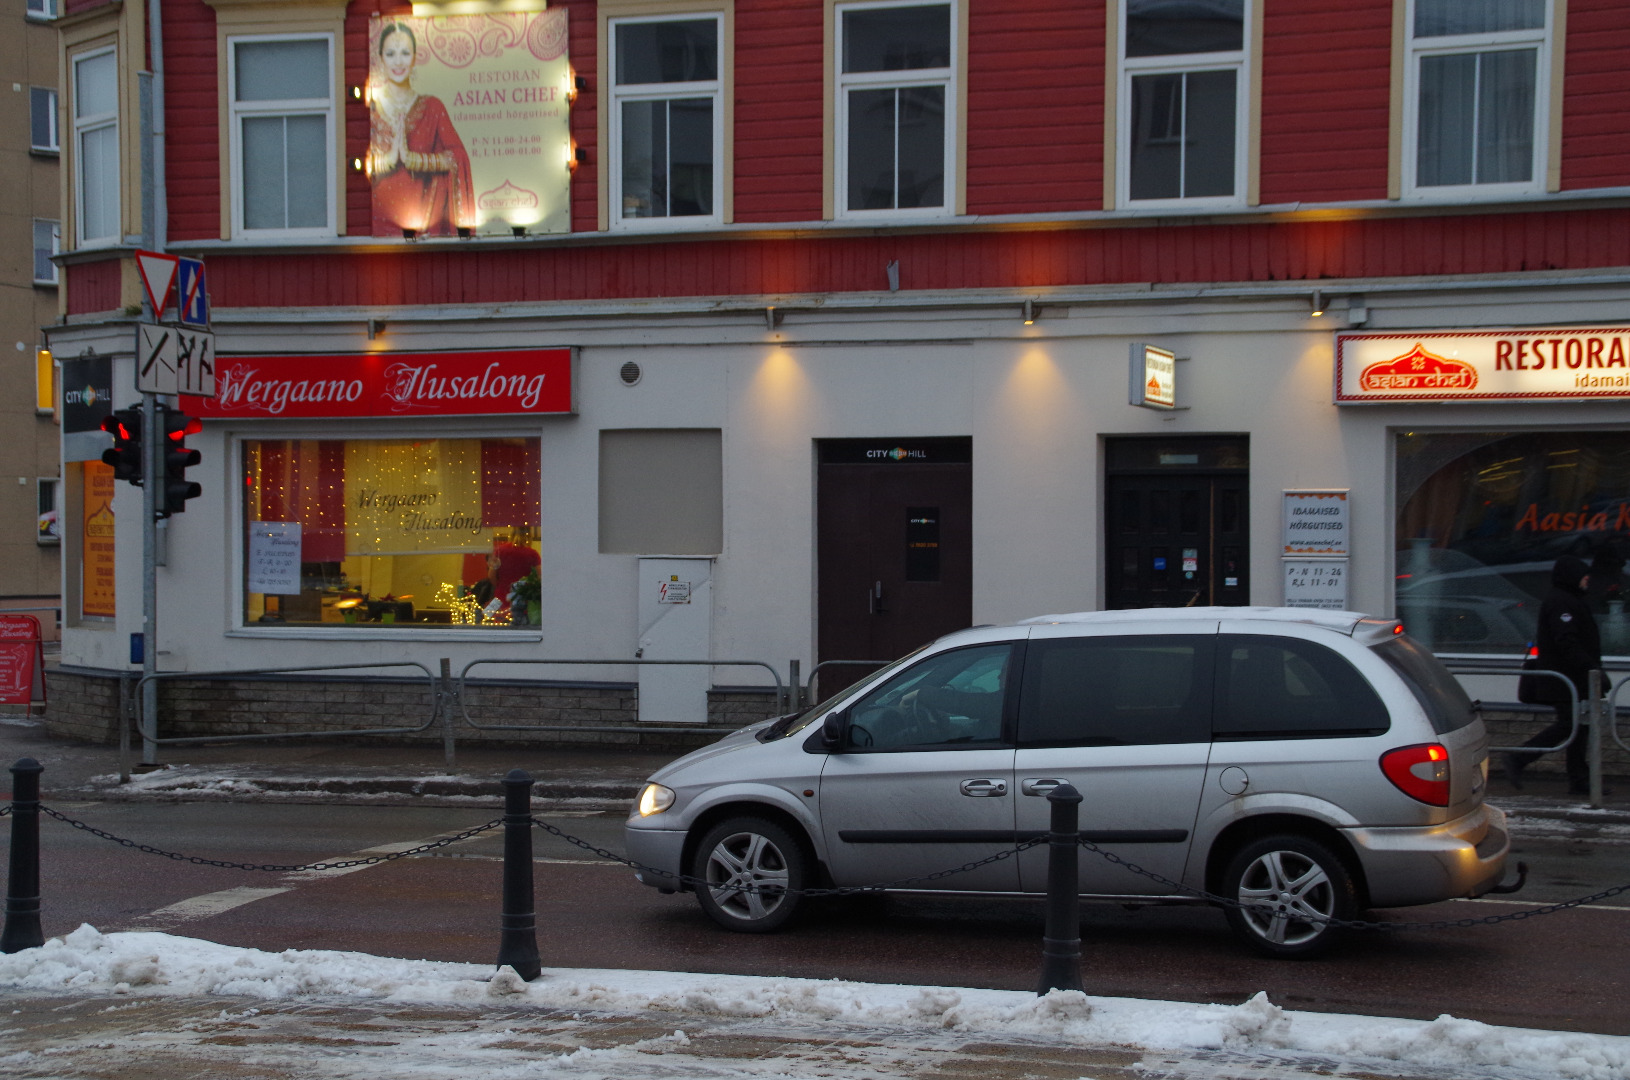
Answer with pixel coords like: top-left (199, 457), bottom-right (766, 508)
top-left (1104, 437), bottom-right (1250, 609)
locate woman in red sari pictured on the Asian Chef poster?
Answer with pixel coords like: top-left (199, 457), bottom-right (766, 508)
top-left (368, 23), bottom-right (476, 236)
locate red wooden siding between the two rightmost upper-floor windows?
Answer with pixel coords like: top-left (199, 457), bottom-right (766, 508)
top-left (1260, 0), bottom-right (1392, 204)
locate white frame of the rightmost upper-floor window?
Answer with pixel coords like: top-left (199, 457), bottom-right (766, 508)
top-left (1400, 0), bottom-right (1558, 202)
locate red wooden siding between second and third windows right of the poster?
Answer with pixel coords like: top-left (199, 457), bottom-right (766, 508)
top-left (967, 0), bottom-right (1105, 213)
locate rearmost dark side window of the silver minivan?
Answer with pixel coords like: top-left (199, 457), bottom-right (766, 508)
top-left (1213, 634), bottom-right (1392, 740)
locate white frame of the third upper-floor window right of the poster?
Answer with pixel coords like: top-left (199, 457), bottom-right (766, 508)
top-left (1112, 0), bottom-right (1260, 210)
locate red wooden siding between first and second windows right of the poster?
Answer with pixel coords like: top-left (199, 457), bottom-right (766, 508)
top-left (735, 0), bottom-right (825, 222)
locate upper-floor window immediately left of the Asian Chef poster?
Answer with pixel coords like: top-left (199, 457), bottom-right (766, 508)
top-left (230, 34), bottom-right (334, 236)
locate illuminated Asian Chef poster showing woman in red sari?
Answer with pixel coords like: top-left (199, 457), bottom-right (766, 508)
top-left (363, 8), bottom-right (574, 236)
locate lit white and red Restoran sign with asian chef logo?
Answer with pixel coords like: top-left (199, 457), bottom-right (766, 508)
top-left (1335, 326), bottom-right (1630, 406)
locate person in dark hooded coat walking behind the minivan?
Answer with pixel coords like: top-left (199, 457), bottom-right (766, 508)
top-left (1504, 555), bottom-right (1602, 795)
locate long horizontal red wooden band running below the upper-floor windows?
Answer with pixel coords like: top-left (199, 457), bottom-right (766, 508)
top-left (68, 209), bottom-right (1630, 314)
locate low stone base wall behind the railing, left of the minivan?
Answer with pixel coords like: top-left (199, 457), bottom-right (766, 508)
top-left (44, 668), bottom-right (778, 751)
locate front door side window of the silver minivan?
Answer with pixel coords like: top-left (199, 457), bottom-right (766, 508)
top-left (846, 643), bottom-right (1014, 751)
